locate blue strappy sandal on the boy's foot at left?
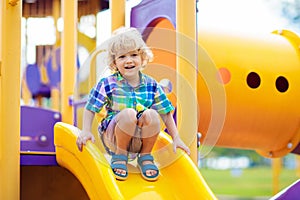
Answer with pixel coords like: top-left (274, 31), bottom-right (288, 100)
top-left (110, 154), bottom-right (128, 181)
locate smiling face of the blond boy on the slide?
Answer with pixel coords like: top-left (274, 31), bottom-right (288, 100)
top-left (115, 50), bottom-right (142, 78)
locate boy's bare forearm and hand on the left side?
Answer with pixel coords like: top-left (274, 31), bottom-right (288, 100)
top-left (76, 109), bottom-right (95, 151)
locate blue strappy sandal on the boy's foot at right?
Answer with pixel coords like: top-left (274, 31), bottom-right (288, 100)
top-left (138, 154), bottom-right (159, 181)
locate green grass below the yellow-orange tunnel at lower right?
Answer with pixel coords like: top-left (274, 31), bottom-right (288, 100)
top-left (200, 167), bottom-right (299, 198)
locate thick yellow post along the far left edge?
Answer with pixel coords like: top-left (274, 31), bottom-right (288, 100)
top-left (0, 0), bottom-right (22, 199)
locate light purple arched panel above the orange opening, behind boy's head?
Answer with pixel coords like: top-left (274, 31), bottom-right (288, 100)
top-left (130, 0), bottom-right (176, 34)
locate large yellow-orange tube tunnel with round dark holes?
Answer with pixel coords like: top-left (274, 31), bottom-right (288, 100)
top-left (197, 28), bottom-right (300, 158)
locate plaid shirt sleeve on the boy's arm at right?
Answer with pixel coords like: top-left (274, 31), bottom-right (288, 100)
top-left (151, 84), bottom-right (174, 114)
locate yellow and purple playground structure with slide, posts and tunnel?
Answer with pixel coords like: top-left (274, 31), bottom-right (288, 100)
top-left (0, 1), bottom-right (300, 199)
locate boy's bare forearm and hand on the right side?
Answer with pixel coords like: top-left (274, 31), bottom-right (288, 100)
top-left (161, 112), bottom-right (190, 155)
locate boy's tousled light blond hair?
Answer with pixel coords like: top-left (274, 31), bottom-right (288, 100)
top-left (107, 27), bottom-right (153, 70)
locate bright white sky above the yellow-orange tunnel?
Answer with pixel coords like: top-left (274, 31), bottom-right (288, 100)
top-left (197, 0), bottom-right (299, 34)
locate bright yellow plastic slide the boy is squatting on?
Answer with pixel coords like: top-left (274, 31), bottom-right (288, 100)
top-left (54, 122), bottom-right (216, 200)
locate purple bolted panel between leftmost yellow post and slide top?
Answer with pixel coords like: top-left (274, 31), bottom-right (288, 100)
top-left (21, 106), bottom-right (61, 165)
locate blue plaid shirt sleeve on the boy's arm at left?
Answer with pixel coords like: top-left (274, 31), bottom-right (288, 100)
top-left (85, 80), bottom-right (107, 113)
